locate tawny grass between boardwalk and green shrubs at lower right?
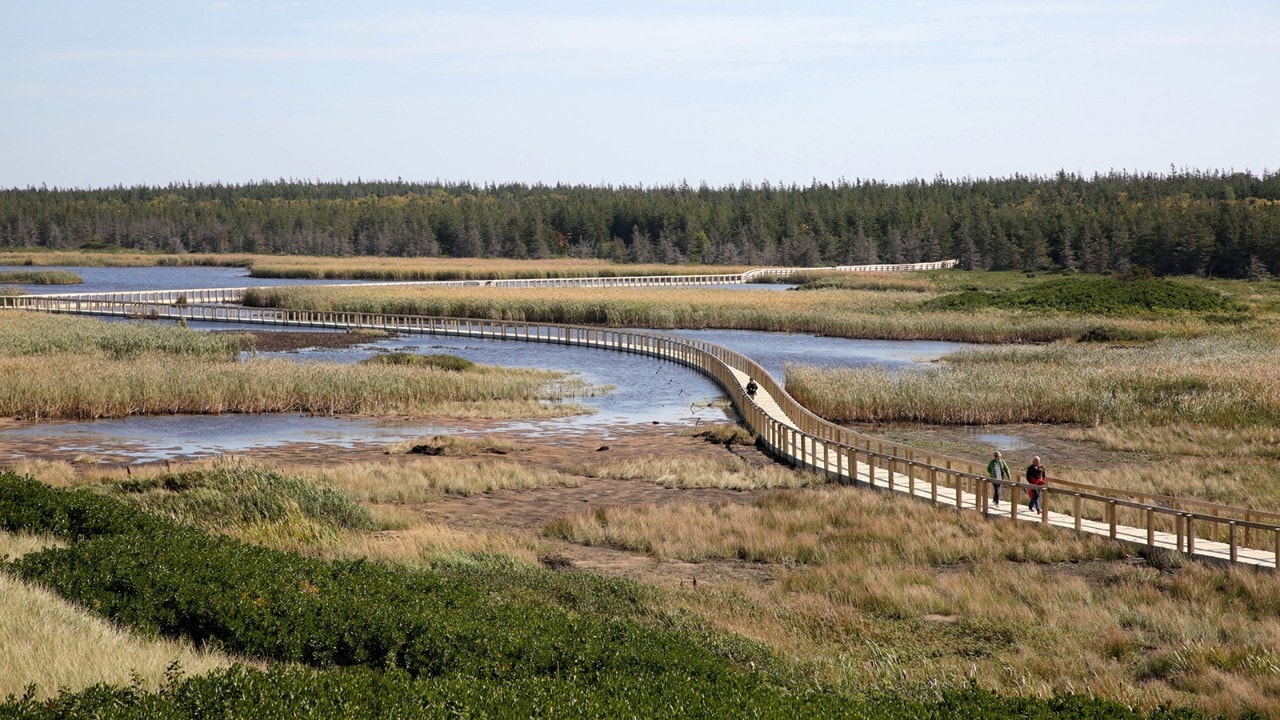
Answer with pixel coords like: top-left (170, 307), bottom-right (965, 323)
top-left (547, 488), bottom-right (1280, 715)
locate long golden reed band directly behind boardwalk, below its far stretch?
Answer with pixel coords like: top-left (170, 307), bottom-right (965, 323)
top-left (244, 286), bottom-right (1211, 342)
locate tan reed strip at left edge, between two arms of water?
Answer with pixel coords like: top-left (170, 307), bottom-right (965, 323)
top-left (0, 352), bottom-right (594, 419)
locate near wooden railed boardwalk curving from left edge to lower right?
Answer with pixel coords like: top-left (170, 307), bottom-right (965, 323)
top-left (0, 256), bottom-right (1280, 570)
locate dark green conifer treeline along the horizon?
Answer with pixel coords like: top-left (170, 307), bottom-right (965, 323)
top-left (0, 170), bottom-right (1280, 278)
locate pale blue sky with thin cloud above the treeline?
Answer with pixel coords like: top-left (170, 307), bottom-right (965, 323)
top-left (0, 0), bottom-right (1280, 188)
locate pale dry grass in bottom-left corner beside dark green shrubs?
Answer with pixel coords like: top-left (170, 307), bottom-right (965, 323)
top-left (0, 533), bottom-right (234, 697)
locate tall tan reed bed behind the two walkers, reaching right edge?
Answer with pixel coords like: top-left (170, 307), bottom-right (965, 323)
top-left (787, 334), bottom-right (1280, 427)
